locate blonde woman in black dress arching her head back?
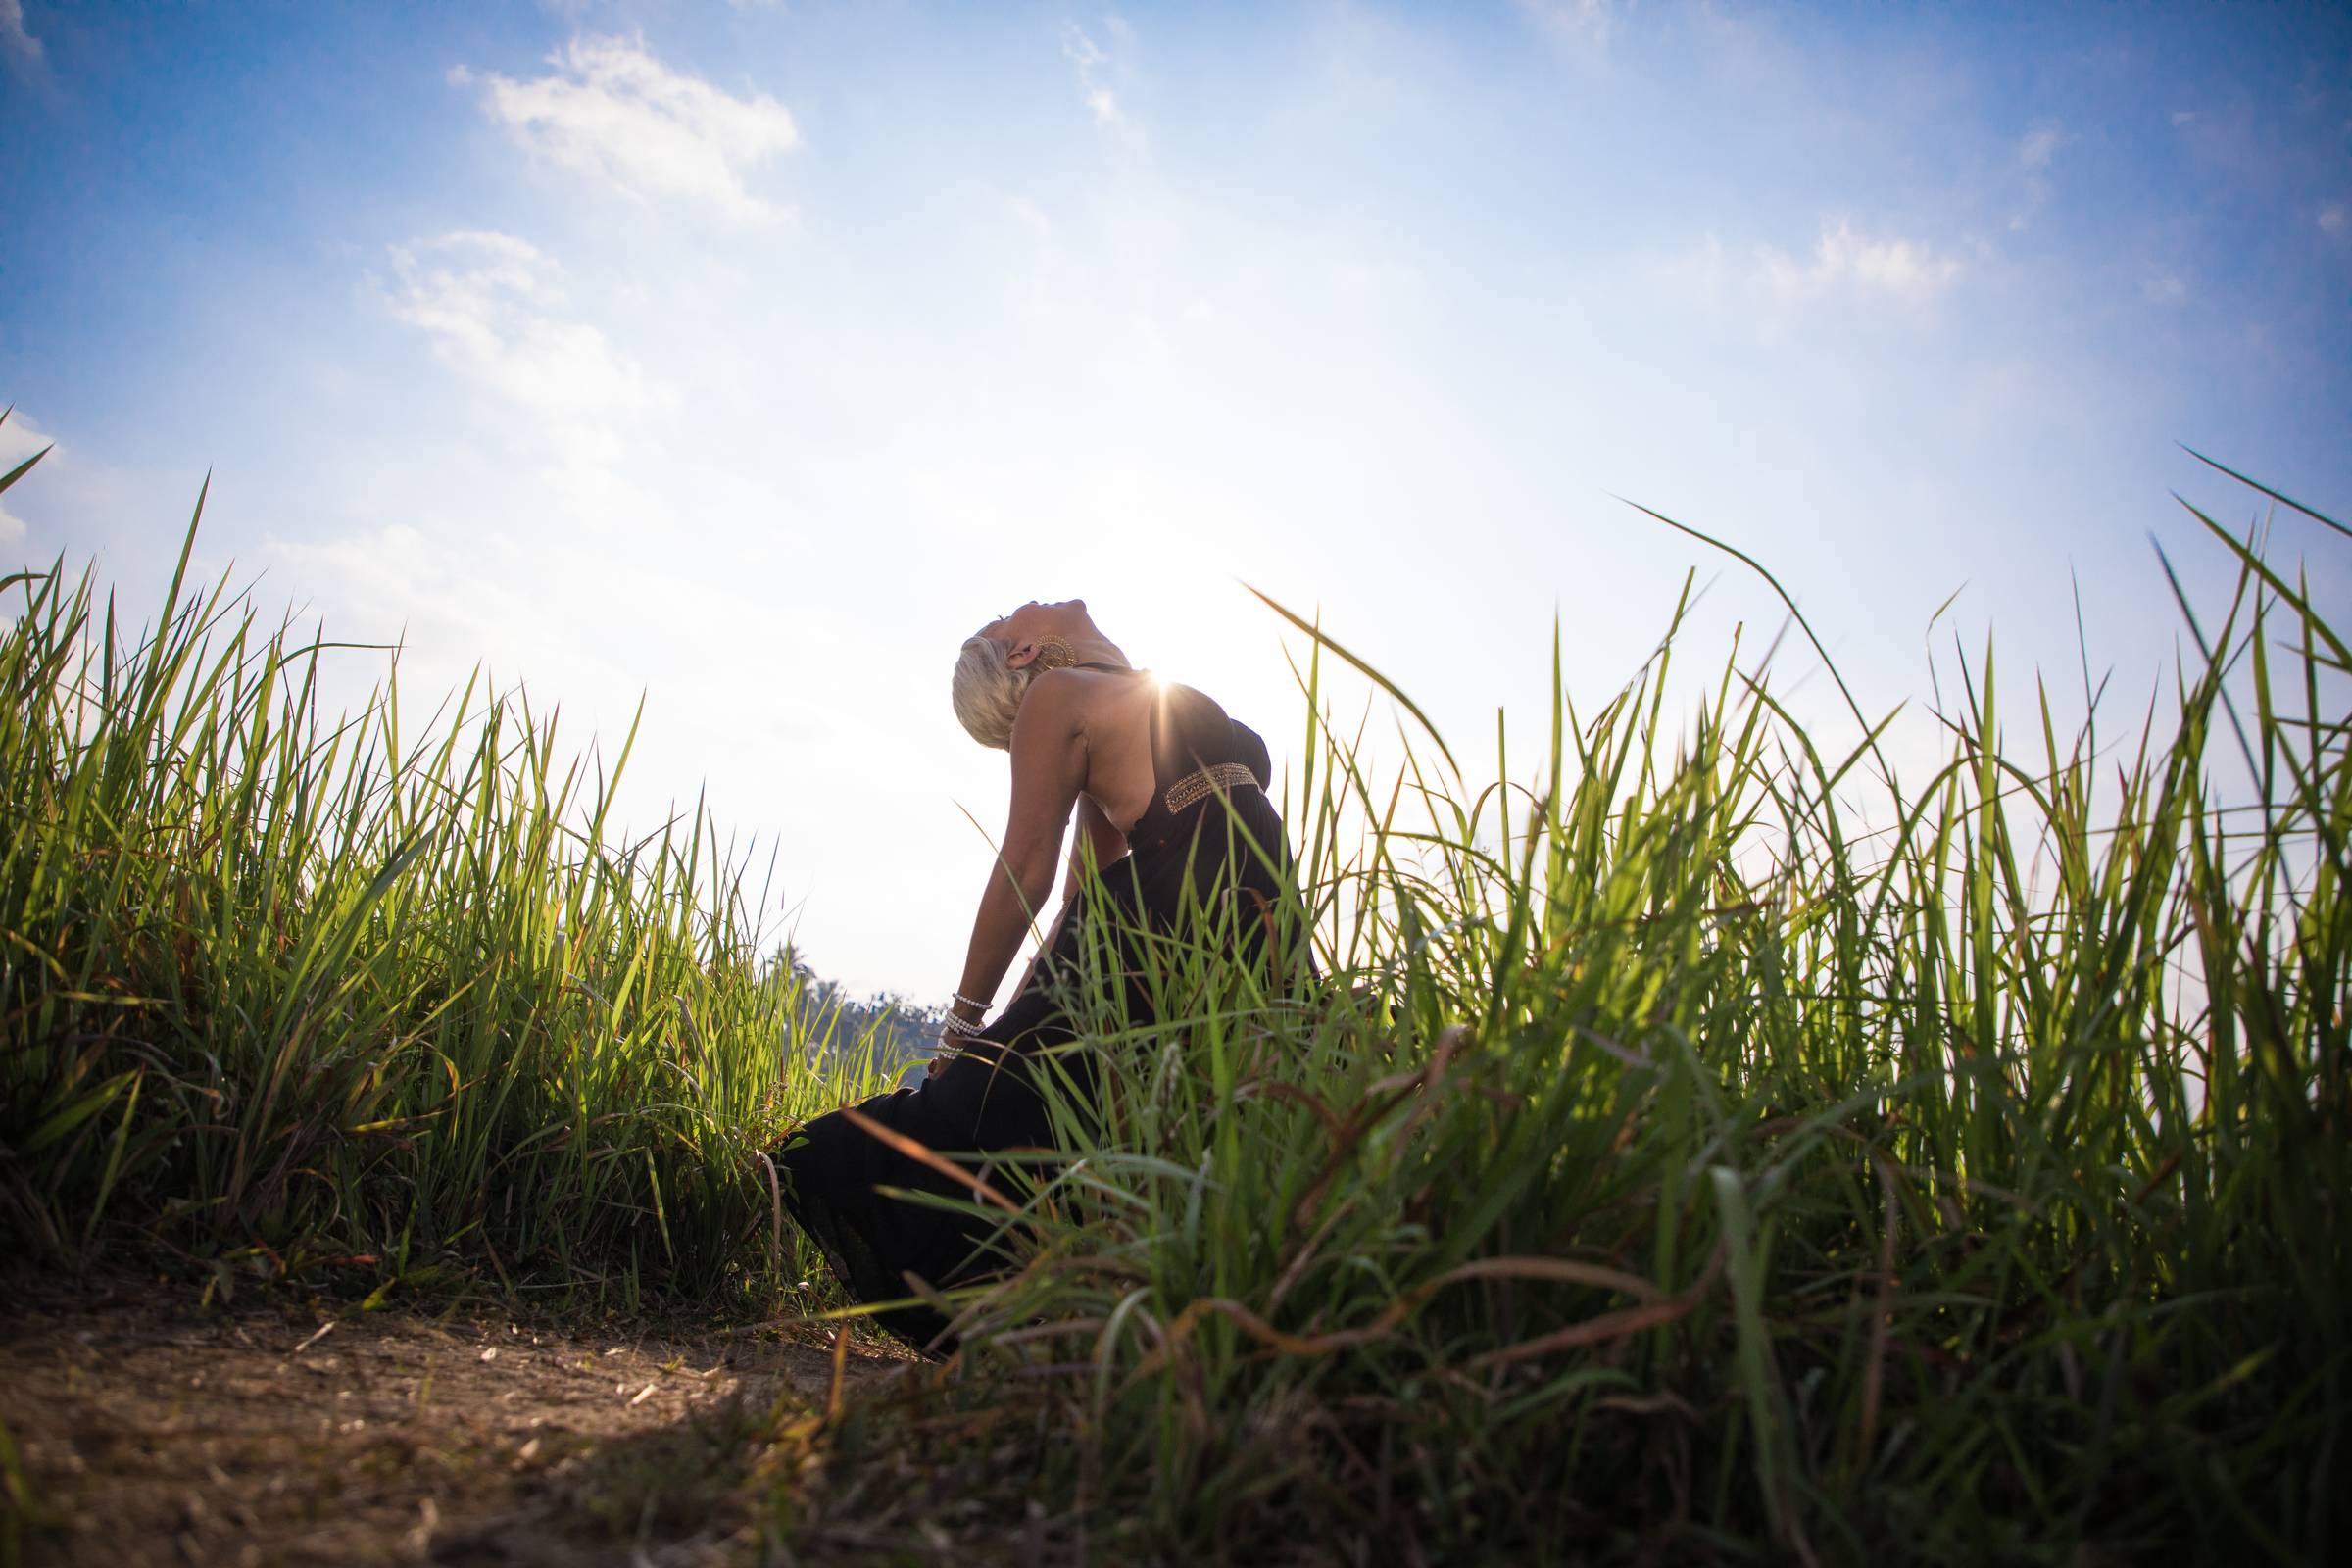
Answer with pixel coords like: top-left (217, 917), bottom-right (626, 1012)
top-left (781, 600), bottom-right (1298, 1348)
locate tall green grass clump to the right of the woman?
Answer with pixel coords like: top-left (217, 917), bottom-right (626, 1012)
top-left (868, 472), bottom-right (2352, 1563)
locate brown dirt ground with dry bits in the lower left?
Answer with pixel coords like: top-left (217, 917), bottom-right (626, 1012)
top-left (0, 1277), bottom-right (906, 1566)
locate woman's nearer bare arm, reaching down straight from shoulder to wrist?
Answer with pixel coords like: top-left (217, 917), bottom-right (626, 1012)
top-left (955, 672), bottom-right (1087, 1022)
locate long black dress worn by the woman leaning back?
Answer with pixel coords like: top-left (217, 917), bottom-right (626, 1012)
top-left (778, 672), bottom-right (1298, 1345)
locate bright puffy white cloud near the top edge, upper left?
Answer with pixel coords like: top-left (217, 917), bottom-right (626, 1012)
top-left (449, 35), bottom-right (800, 220)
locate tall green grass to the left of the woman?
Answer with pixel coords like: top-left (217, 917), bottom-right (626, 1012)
top-left (0, 439), bottom-right (882, 1304)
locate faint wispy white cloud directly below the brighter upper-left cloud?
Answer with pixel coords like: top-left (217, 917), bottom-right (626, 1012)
top-left (386, 230), bottom-right (670, 491)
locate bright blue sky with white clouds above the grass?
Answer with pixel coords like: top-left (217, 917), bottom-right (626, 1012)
top-left (0, 0), bottom-right (2352, 997)
